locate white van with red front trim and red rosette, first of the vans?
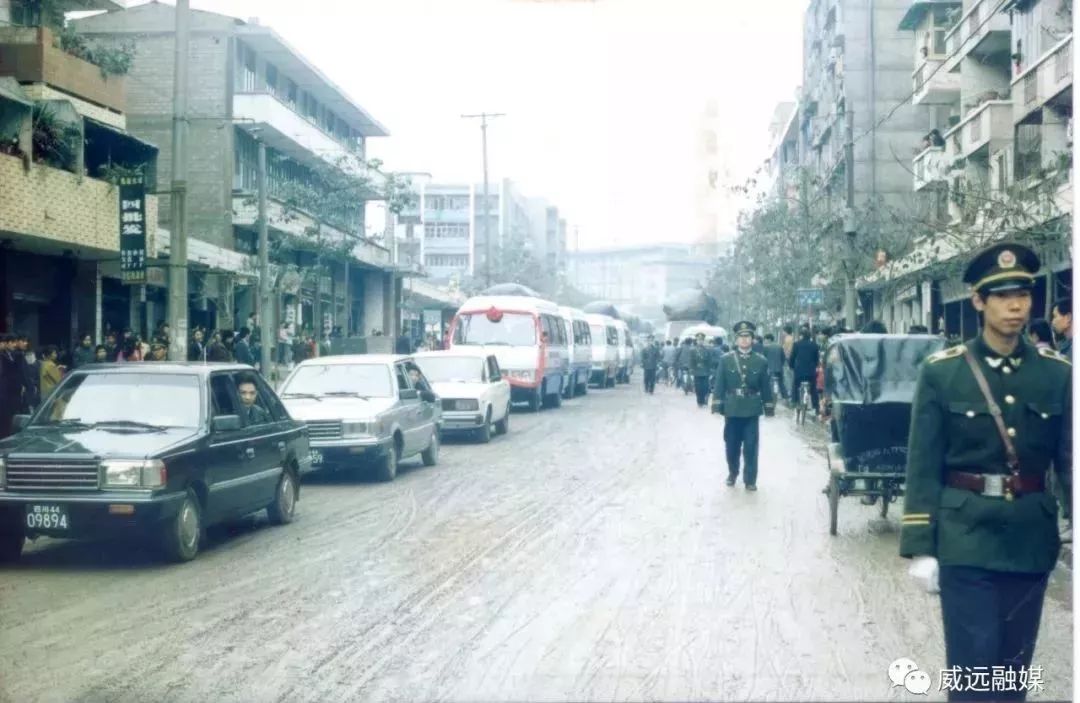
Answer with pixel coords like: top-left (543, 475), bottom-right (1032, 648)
top-left (449, 296), bottom-right (569, 410)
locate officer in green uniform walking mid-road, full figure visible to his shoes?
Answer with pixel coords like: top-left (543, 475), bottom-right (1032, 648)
top-left (713, 322), bottom-right (775, 490)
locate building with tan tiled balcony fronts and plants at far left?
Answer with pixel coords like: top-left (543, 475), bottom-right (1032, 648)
top-left (0, 0), bottom-right (164, 347)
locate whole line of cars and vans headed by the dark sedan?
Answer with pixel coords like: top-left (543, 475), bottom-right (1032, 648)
top-left (0, 296), bottom-right (634, 562)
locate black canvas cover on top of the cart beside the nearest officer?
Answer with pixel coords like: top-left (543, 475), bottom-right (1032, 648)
top-left (825, 335), bottom-right (945, 405)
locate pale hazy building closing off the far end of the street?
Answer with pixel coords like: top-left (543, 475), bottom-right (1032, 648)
top-left (569, 244), bottom-right (715, 320)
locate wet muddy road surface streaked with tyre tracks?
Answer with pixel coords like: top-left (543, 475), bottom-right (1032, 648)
top-left (0, 382), bottom-right (1072, 703)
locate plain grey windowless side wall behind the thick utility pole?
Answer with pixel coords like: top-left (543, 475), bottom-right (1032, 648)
top-left (73, 4), bottom-right (234, 248)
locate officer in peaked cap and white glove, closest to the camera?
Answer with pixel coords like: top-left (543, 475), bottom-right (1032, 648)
top-left (900, 243), bottom-right (1072, 701)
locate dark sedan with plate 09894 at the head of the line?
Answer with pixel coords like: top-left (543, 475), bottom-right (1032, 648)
top-left (0, 363), bottom-right (311, 562)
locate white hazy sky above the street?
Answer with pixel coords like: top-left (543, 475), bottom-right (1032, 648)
top-left (129, 0), bottom-right (806, 248)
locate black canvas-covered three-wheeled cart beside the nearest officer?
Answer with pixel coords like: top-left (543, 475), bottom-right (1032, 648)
top-left (825, 335), bottom-right (945, 535)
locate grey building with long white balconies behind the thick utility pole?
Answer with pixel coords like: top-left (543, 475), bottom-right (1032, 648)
top-left (73, 2), bottom-right (400, 334)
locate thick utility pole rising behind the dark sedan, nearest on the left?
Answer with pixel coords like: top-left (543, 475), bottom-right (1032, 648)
top-left (167, 0), bottom-right (190, 361)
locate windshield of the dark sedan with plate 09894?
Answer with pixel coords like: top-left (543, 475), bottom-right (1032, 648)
top-left (33, 374), bottom-right (202, 428)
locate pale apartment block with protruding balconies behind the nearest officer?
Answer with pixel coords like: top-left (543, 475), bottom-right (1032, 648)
top-left (861, 0), bottom-right (1072, 337)
